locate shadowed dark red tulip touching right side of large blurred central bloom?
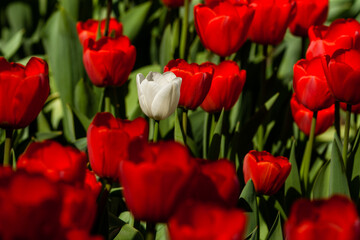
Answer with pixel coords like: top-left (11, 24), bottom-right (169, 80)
top-left (187, 159), bottom-right (240, 207)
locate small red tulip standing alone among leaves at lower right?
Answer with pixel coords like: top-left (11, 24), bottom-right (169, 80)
top-left (243, 150), bottom-right (291, 195)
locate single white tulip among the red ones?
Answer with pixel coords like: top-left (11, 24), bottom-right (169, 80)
top-left (136, 72), bottom-right (182, 120)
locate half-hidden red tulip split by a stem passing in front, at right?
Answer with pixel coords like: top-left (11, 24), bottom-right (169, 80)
top-left (290, 93), bottom-right (335, 136)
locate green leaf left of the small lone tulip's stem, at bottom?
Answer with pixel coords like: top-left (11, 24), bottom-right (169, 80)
top-left (240, 179), bottom-right (259, 239)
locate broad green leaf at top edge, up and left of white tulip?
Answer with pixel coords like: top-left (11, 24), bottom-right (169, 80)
top-left (120, 1), bottom-right (152, 40)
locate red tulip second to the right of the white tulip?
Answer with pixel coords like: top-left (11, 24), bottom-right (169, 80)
top-left (201, 61), bottom-right (246, 113)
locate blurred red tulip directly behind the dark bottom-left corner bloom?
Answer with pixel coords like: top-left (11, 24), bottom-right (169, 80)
top-left (17, 140), bottom-right (87, 186)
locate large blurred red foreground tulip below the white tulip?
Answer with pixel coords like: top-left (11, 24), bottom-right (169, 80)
top-left (120, 140), bottom-right (196, 223)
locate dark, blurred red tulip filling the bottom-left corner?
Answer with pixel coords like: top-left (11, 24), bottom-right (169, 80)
top-left (0, 170), bottom-right (63, 240)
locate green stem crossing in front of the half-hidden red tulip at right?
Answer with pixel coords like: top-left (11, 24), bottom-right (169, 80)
top-left (300, 111), bottom-right (317, 192)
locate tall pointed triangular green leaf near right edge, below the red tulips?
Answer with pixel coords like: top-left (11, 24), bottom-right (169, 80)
top-left (329, 139), bottom-right (350, 197)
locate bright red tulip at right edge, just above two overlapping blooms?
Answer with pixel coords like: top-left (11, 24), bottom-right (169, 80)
top-left (306, 19), bottom-right (360, 59)
